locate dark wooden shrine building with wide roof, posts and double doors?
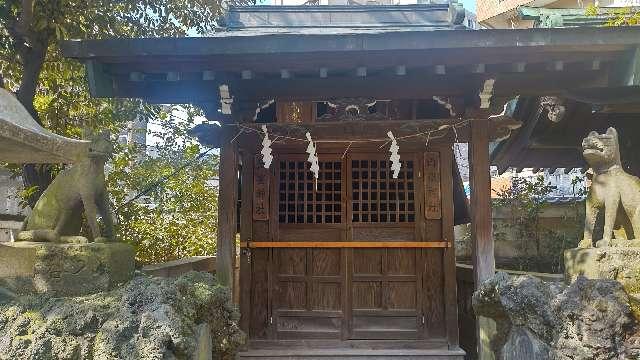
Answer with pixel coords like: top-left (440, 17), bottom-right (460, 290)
top-left (63, 3), bottom-right (640, 359)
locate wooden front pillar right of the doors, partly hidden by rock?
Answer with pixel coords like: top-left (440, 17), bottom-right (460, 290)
top-left (469, 119), bottom-right (495, 360)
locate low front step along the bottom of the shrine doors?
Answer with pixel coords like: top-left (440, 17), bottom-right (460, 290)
top-left (236, 349), bottom-right (465, 360)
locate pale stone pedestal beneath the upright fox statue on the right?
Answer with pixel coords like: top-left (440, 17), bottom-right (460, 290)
top-left (564, 248), bottom-right (640, 319)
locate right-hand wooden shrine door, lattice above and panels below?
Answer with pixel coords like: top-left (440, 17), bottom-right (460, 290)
top-left (347, 154), bottom-right (422, 339)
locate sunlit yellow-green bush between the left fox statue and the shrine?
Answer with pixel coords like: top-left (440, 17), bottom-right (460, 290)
top-left (107, 107), bottom-right (218, 263)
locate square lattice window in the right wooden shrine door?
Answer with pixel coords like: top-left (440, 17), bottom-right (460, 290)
top-left (351, 160), bottom-right (416, 223)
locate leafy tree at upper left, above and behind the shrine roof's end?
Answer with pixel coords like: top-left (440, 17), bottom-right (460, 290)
top-left (0, 0), bottom-right (235, 205)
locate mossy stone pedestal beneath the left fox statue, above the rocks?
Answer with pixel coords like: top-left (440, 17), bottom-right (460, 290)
top-left (0, 242), bottom-right (135, 296)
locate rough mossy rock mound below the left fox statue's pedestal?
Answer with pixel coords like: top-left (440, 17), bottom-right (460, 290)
top-left (0, 272), bottom-right (244, 360)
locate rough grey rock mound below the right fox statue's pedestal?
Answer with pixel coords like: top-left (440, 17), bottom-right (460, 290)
top-left (473, 273), bottom-right (640, 360)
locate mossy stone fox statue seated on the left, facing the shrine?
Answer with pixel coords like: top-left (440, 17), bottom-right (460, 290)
top-left (18, 135), bottom-right (113, 242)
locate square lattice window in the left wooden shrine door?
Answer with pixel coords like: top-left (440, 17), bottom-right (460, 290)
top-left (278, 160), bottom-right (342, 224)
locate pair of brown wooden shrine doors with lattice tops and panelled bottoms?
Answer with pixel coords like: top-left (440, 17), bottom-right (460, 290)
top-left (258, 152), bottom-right (444, 340)
